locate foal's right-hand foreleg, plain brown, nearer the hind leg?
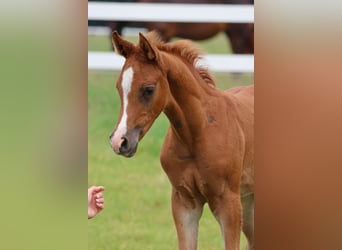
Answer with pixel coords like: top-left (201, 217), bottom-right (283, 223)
top-left (209, 189), bottom-right (242, 250)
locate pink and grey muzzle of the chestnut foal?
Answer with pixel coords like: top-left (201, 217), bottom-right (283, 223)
top-left (109, 128), bottom-right (141, 157)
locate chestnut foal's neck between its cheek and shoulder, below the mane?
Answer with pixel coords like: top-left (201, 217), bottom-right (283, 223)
top-left (163, 52), bottom-right (214, 148)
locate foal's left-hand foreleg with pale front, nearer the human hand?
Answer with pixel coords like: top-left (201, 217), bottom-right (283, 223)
top-left (172, 189), bottom-right (203, 250)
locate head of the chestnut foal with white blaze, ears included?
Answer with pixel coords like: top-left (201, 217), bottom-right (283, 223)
top-left (110, 31), bottom-right (168, 157)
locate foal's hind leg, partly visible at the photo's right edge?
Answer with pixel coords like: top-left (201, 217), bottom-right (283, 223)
top-left (241, 194), bottom-right (254, 250)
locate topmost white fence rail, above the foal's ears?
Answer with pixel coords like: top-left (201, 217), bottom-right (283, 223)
top-left (88, 2), bottom-right (254, 23)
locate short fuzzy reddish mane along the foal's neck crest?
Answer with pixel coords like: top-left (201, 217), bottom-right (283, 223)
top-left (145, 31), bottom-right (216, 87)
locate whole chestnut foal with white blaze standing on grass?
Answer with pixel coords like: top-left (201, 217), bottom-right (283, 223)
top-left (110, 32), bottom-right (254, 250)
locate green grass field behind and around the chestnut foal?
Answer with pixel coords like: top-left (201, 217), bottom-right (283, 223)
top-left (88, 32), bottom-right (254, 250)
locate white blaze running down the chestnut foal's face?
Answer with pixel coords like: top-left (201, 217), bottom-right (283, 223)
top-left (111, 67), bottom-right (134, 153)
